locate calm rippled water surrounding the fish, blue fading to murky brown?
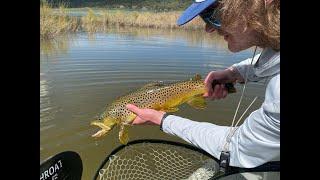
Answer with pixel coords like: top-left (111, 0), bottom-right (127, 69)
top-left (40, 28), bottom-right (265, 179)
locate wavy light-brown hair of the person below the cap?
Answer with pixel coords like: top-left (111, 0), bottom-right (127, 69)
top-left (219, 0), bottom-right (280, 51)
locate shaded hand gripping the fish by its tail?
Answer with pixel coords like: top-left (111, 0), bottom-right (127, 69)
top-left (203, 68), bottom-right (241, 100)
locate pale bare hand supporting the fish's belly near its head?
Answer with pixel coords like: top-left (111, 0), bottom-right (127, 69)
top-left (126, 104), bottom-right (165, 125)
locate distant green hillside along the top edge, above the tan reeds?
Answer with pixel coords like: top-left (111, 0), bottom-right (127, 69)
top-left (40, 0), bottom-right (193, 11)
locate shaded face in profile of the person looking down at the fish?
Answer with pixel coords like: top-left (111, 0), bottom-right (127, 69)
top-left (205, 23), bottom-right (258, 52)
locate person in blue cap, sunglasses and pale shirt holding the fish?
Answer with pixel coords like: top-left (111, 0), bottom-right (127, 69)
top-left (127, 0), bottom-right (280, 168)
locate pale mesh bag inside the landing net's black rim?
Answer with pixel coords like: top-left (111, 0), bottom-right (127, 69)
top-left (97, 142), bottom-right (219, 180)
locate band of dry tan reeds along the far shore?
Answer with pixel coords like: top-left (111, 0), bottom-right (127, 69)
top-left (40, 4), bottom-right (204, 38)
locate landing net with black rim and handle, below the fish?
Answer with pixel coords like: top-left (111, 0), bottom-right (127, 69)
top-left (93, 139), bottom-right (280, 180)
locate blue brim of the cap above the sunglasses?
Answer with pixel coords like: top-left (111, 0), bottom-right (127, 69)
top-left (177, 0), bottom-right (217, 26)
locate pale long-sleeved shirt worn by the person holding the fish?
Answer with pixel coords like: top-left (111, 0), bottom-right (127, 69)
top-left (162, 48), bottom-right (280, 168)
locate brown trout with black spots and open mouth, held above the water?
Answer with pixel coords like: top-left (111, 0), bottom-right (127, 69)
top-left (91, 74), bottom-right (235, 144)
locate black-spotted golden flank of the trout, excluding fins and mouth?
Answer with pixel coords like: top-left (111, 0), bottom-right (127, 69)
top-left (98, 81), bottom-right (204, 125)
